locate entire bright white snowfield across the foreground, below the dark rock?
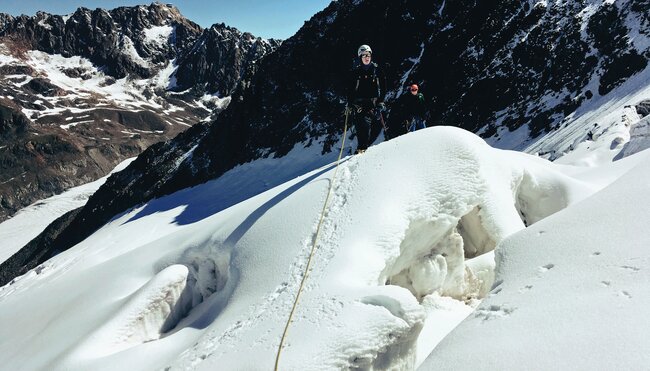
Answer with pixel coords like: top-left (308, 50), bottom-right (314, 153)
top-left (0, 127), bottom-right (650, 370)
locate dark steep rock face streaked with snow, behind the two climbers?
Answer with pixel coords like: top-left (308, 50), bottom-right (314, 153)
top-left (0, 0), bottom-right (650, 288)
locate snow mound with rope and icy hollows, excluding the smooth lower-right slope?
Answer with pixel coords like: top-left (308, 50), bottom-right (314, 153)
top-left (0, 127), bottom-right (647, 370)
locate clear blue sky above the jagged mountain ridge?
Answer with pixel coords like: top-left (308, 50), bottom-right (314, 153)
top-left (0, 0), bottom-right (330, 39)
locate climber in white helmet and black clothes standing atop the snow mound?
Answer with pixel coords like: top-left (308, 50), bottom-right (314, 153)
top-left (348, 45), bottom-right (386, 153)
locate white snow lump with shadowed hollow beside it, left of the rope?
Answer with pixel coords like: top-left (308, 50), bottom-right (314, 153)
top-left (85, 247), bottom-right (238, 356)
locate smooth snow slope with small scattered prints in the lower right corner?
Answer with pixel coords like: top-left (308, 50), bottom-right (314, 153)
top-left (421, 151), bottom-right (650, 370)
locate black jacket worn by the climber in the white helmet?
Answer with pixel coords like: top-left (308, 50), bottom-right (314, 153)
top-left (348, 62), bottom-right (386, 103)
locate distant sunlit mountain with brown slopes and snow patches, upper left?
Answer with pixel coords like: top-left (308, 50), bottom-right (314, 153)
top-left (0, 3), bottom-right (279, 220)
